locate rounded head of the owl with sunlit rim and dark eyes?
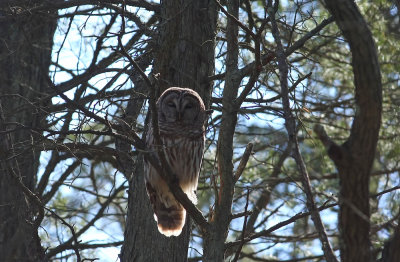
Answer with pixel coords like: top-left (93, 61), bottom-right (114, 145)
top-left (157, 87), bottom-right (207, 127)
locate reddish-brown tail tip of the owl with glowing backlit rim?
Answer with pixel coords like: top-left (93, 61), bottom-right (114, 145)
top-left (154, 206), bottom-right (186, 237)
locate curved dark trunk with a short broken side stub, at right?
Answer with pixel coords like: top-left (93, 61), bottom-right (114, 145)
top-left (315, 0), bottom-right (382, 262)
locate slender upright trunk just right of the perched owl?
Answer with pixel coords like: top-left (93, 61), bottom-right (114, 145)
top-left (203, 0), bottom-right (241, 262)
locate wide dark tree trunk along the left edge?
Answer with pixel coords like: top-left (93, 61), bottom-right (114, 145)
top-left (0, 1), bottom-right (57, 262)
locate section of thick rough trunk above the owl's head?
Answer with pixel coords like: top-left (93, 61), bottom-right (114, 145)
top-left (154, 0), bottom-right (217, 104)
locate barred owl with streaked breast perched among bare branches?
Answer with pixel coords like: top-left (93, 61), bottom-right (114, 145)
top-left (144, 87), bottom-right (207, 236)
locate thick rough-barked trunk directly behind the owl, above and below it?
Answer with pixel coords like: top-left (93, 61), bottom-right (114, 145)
top-left (121, 0), bottom-right (217, 262)
